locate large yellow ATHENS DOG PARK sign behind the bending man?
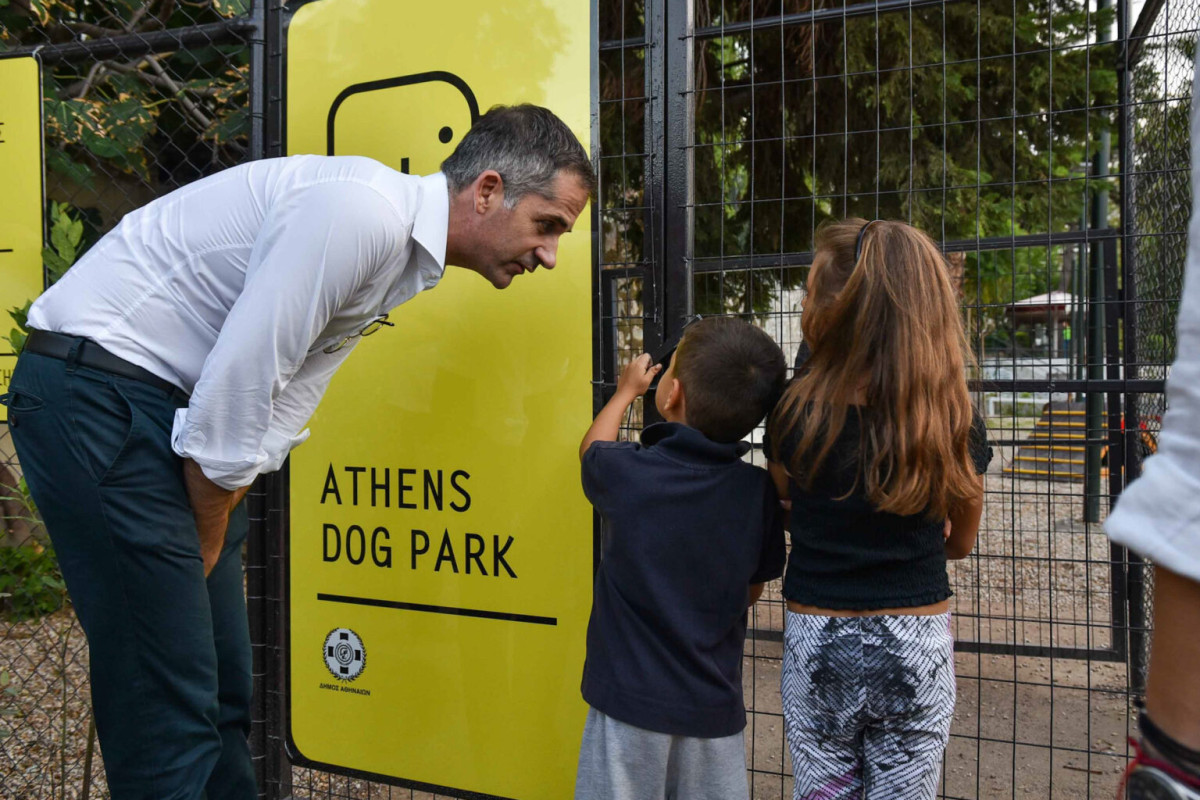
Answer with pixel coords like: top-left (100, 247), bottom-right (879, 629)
top-left (287, 0), bottom-right (593, 800)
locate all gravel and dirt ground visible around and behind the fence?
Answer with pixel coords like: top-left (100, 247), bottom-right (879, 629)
top-left (0, 447), bottom-right (1132, 800)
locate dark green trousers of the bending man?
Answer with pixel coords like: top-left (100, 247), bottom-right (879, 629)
top-left (6, 353), bottom-right (257, 800)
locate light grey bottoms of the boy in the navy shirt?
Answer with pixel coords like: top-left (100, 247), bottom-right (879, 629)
top-left (575, 709), bottom-right (750, 800)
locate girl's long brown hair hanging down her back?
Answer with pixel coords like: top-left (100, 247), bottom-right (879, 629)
top-left (769, 218), bottom-right (979, 518)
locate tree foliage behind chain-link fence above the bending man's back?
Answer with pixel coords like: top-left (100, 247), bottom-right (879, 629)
top-left (0, 0), bottom-right (248, 236)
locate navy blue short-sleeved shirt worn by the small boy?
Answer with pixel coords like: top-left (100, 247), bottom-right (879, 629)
top-left (583, 422), bottom-right (785, 738)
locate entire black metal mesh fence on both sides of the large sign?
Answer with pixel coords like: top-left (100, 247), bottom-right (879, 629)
top-left (0, 0), bottom-right (1200, 799)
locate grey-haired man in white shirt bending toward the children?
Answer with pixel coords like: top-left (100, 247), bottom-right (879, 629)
top-left (5, 106), bottom-right (595, 800)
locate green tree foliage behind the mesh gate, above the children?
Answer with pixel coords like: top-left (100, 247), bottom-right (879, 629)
top-left (600, 0), bottom-right (1117, 331)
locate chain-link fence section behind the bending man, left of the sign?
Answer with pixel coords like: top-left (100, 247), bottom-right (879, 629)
top-left (0, 0), bottom-right (251, 800)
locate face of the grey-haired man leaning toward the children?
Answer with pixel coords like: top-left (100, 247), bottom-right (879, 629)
top-left (473, 173), bottom-right (588, 289)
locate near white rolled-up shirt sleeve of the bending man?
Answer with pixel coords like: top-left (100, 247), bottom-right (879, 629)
top-left (172, 182), bottom-right (408, 489)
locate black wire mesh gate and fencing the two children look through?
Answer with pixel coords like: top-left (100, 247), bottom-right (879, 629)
top-left (601, 0), bottom-right (1196, 798)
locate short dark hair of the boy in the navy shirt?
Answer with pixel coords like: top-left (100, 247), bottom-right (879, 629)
top-left (674, 317), bottom-right (787, 443)
